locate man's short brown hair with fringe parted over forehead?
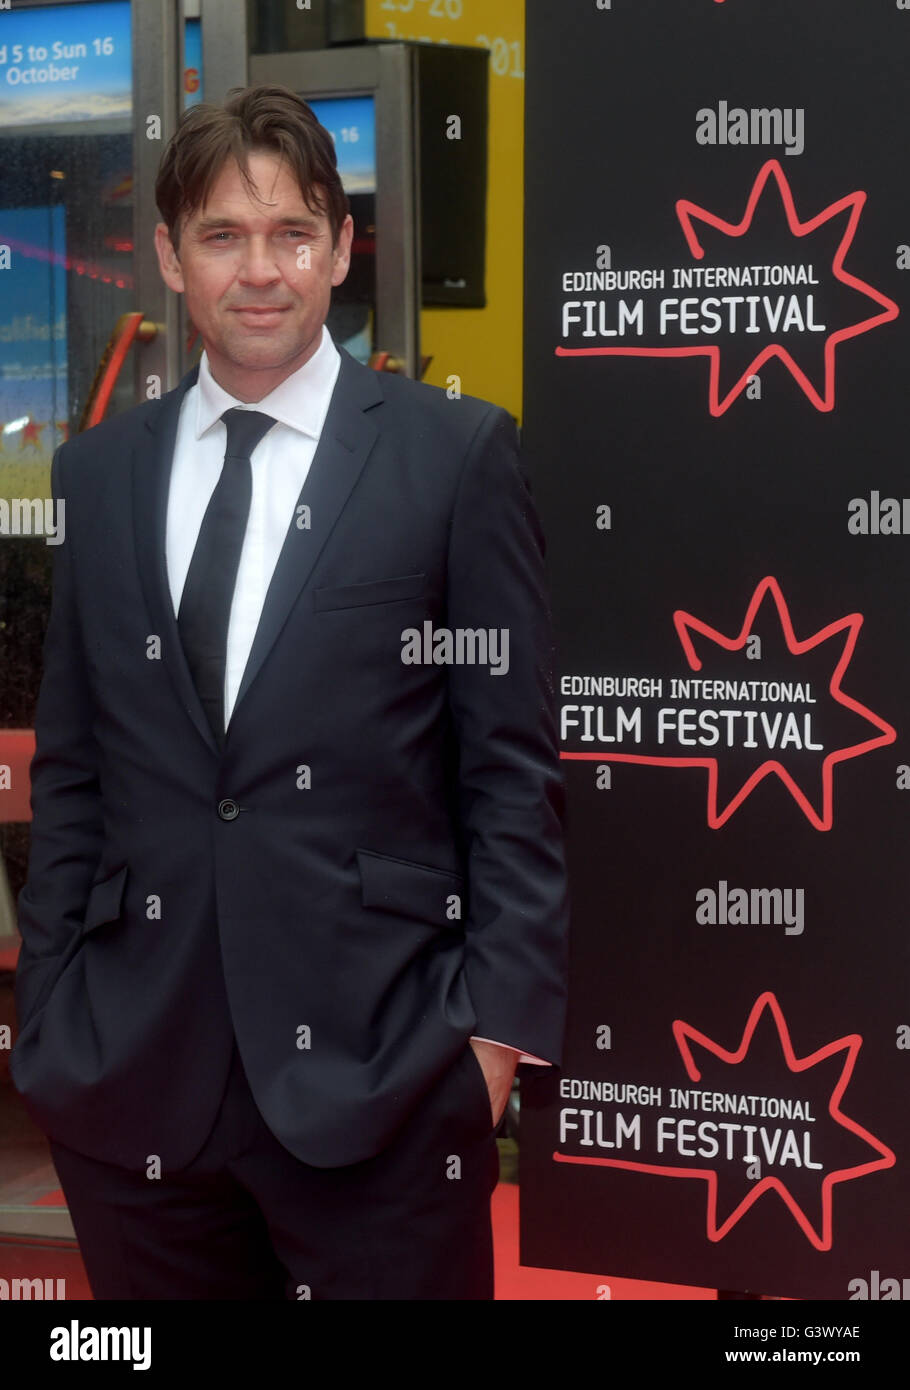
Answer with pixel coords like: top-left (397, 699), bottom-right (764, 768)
top-left (154, 85), bottom-right (350, 250)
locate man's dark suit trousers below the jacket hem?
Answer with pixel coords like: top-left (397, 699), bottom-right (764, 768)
top-left (50, 1043), bottom-right (499, 1301)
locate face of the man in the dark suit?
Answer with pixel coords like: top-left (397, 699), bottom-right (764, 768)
top-left (156, 150), bottom-right (354, 402)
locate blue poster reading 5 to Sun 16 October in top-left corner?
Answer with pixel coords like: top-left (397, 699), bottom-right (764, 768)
top-left (0, 0), bottom-right (132, 129)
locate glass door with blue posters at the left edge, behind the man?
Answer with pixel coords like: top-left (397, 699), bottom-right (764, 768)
top-left (0, 0), bottom-right (223, 1251)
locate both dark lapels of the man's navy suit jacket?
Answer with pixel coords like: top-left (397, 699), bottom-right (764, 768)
top-left (133, 348), bottom-right (383, 753)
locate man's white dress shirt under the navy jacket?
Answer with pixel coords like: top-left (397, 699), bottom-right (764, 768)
top-left (165, 325), bottom-right (550, 1066)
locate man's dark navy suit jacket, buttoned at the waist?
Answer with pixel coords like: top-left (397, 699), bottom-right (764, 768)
top-left (11, 352), bottom-right (568, 1169)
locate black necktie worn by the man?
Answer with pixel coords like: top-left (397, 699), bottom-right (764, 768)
top-left (176, 409), bottom-right (275, 748)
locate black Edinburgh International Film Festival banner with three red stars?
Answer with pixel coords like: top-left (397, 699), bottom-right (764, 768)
top-left (521, 0), bottom-right (910, 1300)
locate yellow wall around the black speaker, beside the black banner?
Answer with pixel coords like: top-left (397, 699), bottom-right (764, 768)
top-left (367, 0), bottom-right (525, 418)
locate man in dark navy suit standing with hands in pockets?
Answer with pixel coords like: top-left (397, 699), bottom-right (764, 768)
top-left (11, 88), bottom-right (567, 1298)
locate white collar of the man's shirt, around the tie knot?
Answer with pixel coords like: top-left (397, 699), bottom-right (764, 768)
top-left (196, 324), bottom-right (340, 439)
